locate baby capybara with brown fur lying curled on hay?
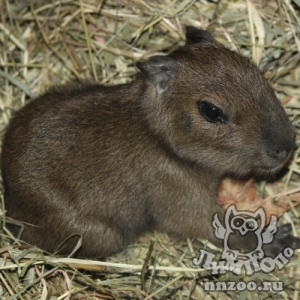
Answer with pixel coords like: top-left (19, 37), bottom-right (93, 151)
top-left (2, 27), bottom-right (295, 257)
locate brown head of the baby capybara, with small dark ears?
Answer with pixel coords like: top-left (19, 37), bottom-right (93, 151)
top-left (138, 27), bottom-right (295, 176)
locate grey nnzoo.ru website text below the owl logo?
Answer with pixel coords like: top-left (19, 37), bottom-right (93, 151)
top-left (203, 281), bottom-right (284, 292)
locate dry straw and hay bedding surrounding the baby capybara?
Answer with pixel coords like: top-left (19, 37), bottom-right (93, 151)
top-left (0, 0), bottom-right (300, 299)
